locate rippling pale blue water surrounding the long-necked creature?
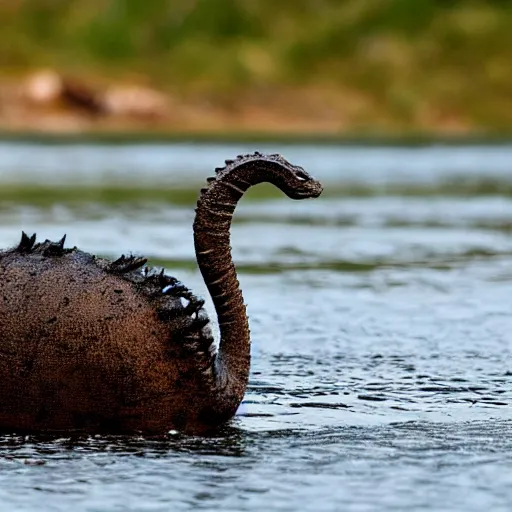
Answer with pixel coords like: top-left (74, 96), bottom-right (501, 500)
top-left (0, 144), bottom-right (512, 512)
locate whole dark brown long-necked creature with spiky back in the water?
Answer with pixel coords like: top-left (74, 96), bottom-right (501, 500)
top-left (0, 153), bottom-right (322, 434)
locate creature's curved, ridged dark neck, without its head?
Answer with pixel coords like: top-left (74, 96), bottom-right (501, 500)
top-left (194, 161), bottom-right (268, 400)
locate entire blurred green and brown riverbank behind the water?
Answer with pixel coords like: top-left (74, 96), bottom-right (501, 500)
top-left (0, 0), bottom-right (512, 137)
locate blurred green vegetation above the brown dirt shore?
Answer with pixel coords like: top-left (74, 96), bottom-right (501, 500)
top-left (0, 0), bottom-right (512, 133)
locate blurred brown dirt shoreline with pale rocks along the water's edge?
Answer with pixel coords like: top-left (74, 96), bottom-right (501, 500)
top-left (0, 70), bottom-right (499, 140)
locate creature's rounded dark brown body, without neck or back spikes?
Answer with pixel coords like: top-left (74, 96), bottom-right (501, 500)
top-left (0, 246), bottom-right (224, 433)
